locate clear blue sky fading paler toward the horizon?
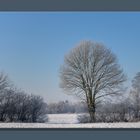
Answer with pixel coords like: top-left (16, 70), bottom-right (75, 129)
top-left (0, 12), bottom-right (140, 102)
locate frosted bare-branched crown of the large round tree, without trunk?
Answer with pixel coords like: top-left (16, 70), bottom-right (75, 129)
top-left (61, 41), bottom-right (125, 99)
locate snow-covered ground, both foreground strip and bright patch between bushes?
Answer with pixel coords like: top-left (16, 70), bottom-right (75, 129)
top-left (0, 114), bottom-right (140, 128)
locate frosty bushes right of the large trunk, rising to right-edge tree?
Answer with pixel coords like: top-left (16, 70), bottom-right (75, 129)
top-left (96, 72), bottom-right (140, 122)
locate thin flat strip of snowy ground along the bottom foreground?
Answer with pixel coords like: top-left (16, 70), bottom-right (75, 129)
top-left (0, 122), bottom-right (140, 128)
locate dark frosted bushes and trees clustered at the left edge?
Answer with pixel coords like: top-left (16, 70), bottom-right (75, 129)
top-left (0, 73), bottom-right (47, 122)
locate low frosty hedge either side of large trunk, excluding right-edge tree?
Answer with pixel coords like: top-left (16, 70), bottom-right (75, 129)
top-left (78, 94), bottom-right (140, 123)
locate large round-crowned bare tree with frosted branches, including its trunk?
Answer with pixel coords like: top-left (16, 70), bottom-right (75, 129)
top-left (60, 41), bottom-right (126, 122)
